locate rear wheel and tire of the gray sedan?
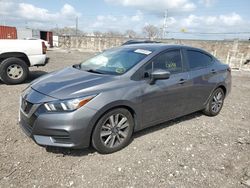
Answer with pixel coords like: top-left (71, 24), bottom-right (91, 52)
top-left (203, 88), bottom-right (225, 116)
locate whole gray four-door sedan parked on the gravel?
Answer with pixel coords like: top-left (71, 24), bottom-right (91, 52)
top-left (19, 44), bottom-right (231, 153)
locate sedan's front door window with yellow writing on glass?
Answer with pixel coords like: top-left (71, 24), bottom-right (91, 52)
top-left (145, 50), bottom-right (182, 74)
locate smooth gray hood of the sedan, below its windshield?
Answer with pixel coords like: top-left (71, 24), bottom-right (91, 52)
top-left (31, 67), bottom-right (119, 99)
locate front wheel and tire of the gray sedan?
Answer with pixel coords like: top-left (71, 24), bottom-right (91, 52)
top-left (91, 108), bottom-right (134, 154)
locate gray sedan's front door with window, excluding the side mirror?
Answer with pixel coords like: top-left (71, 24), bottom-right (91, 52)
top-left (141, 50), bottom-right (190, 127)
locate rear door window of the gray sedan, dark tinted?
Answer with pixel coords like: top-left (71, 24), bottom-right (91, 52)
top-left (187, 50), bottom-right (212, 70)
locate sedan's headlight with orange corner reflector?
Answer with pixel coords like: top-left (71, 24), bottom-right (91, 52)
top-left (44, 95), bottom-right (96, 112)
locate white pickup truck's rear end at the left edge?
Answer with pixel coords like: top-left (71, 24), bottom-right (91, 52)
top-left (0, 39), bottom-right (48, 84)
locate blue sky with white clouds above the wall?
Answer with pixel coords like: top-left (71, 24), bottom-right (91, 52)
top-left (0, 0), bottom-right (250, 39)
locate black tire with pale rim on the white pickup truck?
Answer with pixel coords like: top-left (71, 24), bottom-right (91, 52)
top-left (0, 57), bottom-right (29, 84)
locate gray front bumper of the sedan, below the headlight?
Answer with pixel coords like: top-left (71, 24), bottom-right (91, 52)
top-left (19, 97), bottom-right (96, 148)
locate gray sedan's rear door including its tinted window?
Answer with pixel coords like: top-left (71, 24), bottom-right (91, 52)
top-left (184, 49), bottom-right (217, 112)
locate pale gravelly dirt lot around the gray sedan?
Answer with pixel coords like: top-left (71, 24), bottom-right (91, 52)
top-left (0, 51), bottom-right (250, 188)
